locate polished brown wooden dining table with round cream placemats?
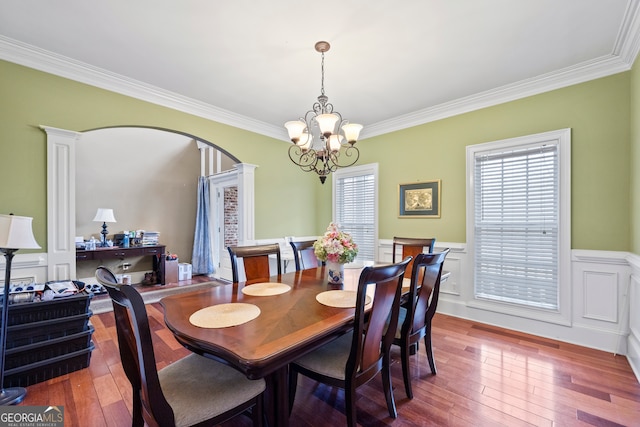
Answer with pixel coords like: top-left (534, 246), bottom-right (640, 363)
top-left (160, 266), bottom-right (370, 426)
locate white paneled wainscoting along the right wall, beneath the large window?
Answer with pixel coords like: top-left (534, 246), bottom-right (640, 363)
top-left (378, 240), bottom-right (640, 379)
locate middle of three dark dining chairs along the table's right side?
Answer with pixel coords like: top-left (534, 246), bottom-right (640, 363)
top-left (393, 249), bottom-right (449, 399)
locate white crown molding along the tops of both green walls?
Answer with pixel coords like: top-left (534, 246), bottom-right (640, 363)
top-left (0, 12), bottom-right (640, 141)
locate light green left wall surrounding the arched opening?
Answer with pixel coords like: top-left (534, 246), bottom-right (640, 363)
top-left (0, 61), bottom-right (317, 248)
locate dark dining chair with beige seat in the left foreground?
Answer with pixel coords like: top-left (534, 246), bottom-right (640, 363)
top-left (96, 266), bottom-right (265, 427)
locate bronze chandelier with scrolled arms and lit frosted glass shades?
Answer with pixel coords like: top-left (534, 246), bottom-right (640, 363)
top-left (284, 41), bottom-right (362, 184)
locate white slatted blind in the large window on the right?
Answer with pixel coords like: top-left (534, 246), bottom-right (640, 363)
top-left (474, 141), bottom-right (560, 310)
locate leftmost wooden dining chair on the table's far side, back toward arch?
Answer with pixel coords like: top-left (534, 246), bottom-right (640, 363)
top-left (227, 243), bottom-right (282, 283)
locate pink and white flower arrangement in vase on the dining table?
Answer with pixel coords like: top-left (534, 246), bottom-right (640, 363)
top-left (313, 222), bottom-right (358, 284)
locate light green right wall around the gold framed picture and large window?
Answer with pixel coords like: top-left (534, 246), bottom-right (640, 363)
top-left (359, 73), bottom-right (630, 251)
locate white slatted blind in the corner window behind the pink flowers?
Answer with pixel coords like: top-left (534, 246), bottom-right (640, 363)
top-left (335, 174), bottom-right (376, 261)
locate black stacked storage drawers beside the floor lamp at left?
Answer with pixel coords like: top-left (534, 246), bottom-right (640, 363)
top-left (0, 292), bottom-right (93, 387)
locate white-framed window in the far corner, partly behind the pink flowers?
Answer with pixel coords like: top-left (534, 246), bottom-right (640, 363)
top-left (333, 163), bottom-right (378, 262)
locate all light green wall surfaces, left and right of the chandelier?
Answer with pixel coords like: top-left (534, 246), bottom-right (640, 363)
top-left (0, 61), bottom-right (640, 251)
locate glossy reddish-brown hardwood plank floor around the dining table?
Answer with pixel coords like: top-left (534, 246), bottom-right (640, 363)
top-left (17, 284), bottom-right (640, 427)
